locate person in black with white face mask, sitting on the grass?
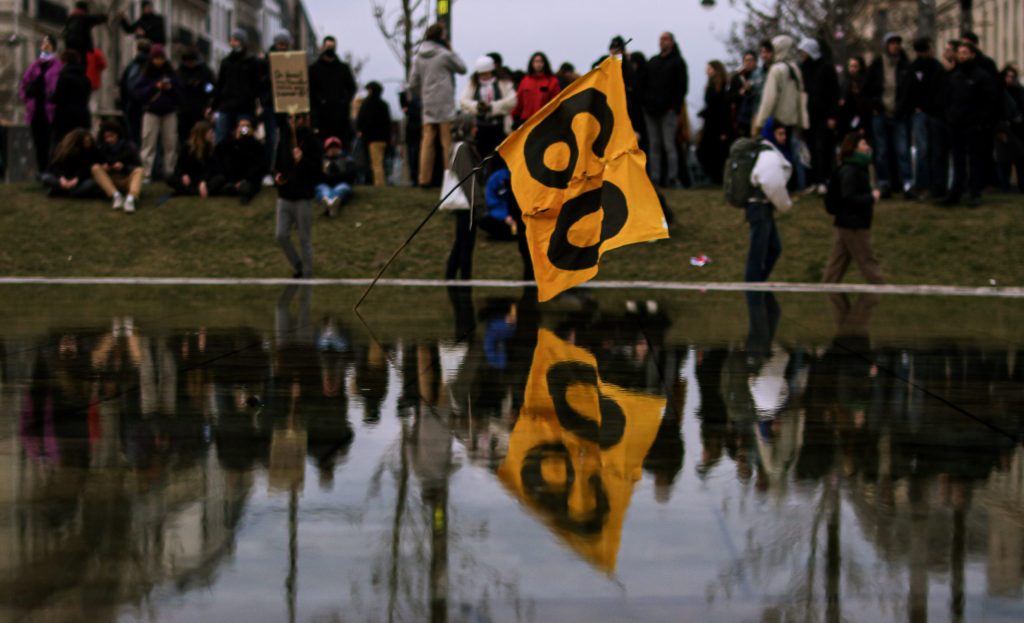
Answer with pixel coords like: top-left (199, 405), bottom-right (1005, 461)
top-left (209, 117), bottom-right (267, 205)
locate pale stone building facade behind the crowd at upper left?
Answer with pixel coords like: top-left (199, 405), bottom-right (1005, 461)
top-left (0, 0), bottom-right (316, 124)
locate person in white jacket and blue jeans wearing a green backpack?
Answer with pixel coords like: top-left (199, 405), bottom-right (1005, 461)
top-left (743, 118), bottom-right (793, 282)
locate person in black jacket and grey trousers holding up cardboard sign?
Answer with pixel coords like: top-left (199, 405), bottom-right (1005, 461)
top-left (273, 115), bottom-right (323, 279)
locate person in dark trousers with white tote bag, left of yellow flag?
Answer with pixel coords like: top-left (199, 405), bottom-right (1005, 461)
top-left (444, 115), bottom-right (484, 281)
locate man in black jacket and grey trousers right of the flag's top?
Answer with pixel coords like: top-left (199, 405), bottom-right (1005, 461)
top-left (643, 32), bottom-right (689, 186)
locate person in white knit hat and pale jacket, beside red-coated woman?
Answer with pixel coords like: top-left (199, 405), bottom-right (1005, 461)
top-left (459, 56), bottom-right (516, 160)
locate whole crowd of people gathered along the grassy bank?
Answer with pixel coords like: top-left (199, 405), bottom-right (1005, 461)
top-left (20, 2), bottom-right (1024, 282)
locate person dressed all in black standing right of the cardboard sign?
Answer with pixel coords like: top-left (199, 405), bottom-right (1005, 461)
top-left (309, 36), bottom-right (355, 146)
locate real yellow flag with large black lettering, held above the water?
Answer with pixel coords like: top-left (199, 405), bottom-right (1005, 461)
top-left (498, 57), bottom-right (669, 301)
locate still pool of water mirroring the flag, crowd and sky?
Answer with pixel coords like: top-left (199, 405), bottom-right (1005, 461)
top-left (0, 286), bottom-right (1024, 623)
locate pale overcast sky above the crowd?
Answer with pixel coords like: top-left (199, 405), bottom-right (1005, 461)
top-left (306, 0), bottom-right (739, 114)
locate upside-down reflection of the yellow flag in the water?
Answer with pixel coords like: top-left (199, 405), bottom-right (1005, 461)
top-left (498, 329), bottom-right (665, 573)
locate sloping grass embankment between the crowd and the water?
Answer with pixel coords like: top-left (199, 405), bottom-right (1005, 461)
top-left (0, 184), bottom-right (1024, 286)
